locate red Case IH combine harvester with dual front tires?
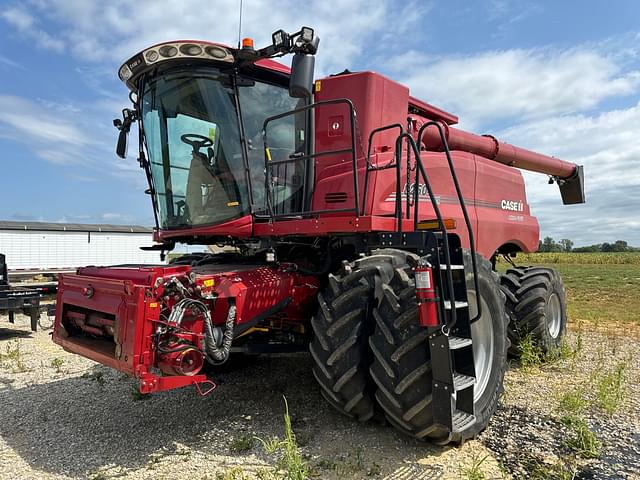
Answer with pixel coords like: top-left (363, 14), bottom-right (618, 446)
top-left (53, 27), bottom-right (584, 443)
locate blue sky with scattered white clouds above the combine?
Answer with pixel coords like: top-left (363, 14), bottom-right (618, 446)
top-left (0, 0), bottom-right (640, 245)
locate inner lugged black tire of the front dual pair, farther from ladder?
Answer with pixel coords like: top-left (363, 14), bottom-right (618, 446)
top-left (309, 250), bottom-right (420, 422)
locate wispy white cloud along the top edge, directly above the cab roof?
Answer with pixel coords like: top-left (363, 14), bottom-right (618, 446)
top-left (4, 0), bottom-right (420, 73)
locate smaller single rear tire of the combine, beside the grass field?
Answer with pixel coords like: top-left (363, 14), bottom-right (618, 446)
top-left (500, 267), bottom-right (567, 356)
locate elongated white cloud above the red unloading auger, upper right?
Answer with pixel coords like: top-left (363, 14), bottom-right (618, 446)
top-left (391, 45), bottom-right (640, 127)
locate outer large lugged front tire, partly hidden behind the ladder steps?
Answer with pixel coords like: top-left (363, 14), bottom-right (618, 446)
top-left (370, 252), bottom-right (508, 443)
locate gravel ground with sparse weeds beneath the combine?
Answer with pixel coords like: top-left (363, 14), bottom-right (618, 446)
top-left (0, 317), bottom-right (640, 480)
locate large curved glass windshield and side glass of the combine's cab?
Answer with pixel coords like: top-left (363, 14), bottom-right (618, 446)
top-left (141, 67), bottom-right (300, 229)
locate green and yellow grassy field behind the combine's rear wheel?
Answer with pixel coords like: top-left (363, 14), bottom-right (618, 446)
top-left (498, 253), bottom-right (640, 327)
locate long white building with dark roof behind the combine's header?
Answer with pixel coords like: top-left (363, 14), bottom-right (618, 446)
top-left (0, 221), bottom-right (163, 272)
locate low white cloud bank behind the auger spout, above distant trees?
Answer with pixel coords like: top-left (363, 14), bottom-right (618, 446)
top-left (498, 104), bottom-right (640, 245)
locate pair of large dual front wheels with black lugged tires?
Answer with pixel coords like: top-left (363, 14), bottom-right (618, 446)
top-left (310, 249), bottom-right (508, 443)
